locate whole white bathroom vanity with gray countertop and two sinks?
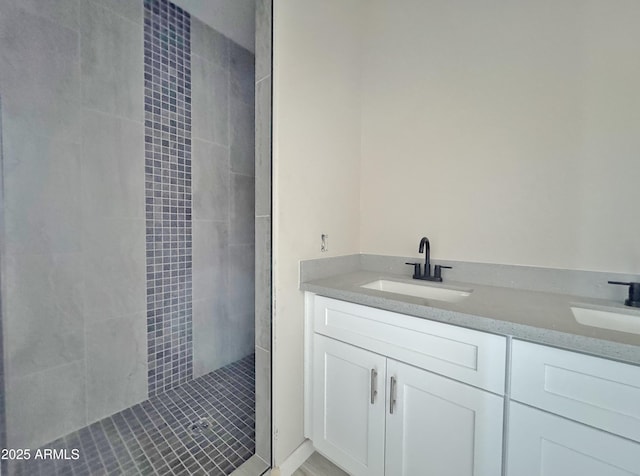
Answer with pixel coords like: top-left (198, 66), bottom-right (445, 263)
top-left (301, 272), bottom-right (640, 476)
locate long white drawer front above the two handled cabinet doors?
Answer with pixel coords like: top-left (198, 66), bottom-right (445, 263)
top-left (313, 296), bottom-right (506, 395)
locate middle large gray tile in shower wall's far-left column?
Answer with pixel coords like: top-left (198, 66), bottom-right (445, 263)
top-left (3, 131), bottom-right (81, 253)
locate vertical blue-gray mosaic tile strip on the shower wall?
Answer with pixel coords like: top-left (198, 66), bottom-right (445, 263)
top-left (144, 0), bottom-right (193, 395)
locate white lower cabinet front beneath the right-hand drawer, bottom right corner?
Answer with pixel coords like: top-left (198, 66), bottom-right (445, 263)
top-left (507, 402), bottom-right (640, 476)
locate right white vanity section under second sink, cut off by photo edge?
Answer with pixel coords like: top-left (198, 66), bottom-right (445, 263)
top-left (507, 340), bottom-right (640, 476)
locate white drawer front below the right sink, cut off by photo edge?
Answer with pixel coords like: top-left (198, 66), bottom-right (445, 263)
top-left (511, 340), bottom-right (640, 442)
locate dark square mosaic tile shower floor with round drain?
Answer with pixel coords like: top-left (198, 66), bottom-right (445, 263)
top-left (9, 354), bottom-right (255, 476)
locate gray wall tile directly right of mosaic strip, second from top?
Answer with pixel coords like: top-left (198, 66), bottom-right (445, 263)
top-left (191, 55), bottom-right (229, 146)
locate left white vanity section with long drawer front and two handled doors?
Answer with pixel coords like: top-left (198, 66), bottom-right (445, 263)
top-left (305, 295), bottom-right (506, 476)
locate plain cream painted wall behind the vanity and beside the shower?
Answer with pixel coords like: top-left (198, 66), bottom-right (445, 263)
top-left (273, 0), bottom-right (640, 464)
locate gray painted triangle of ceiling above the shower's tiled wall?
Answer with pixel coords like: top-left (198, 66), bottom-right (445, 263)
top-left (173, 0), bottom-right (256, 52)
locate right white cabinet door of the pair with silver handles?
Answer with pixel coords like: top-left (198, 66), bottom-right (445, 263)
top-left (385, 359), bottom-right (503, 476)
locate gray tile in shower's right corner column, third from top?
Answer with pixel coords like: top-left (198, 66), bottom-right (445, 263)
top-left (229, 174), bottom-right (255, 245)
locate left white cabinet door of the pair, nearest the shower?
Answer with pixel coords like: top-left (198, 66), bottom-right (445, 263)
top-left (312, 334), bottom-right (386, 476)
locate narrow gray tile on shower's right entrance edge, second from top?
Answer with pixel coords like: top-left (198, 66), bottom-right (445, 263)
top-left (255, 76), bottom-right (271, 216)
